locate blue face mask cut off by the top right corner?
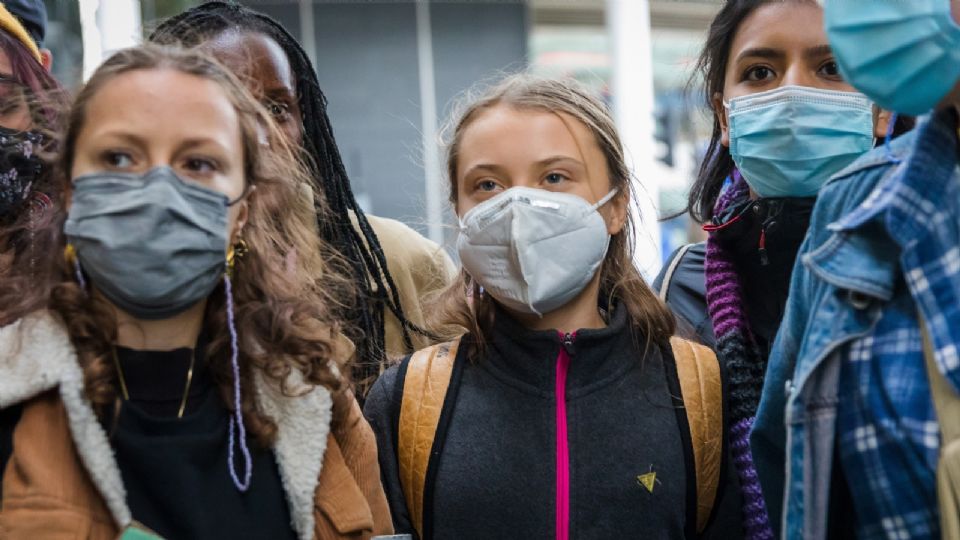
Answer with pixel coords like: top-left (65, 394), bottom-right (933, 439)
top-left (823, 0), bottom-right (960, 115)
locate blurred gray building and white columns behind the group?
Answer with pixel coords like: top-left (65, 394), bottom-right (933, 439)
top-left (46, 0), bottom-right (721, 274)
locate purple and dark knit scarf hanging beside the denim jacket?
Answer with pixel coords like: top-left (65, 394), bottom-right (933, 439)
top-left (705, 172), bottom-right (774, 540)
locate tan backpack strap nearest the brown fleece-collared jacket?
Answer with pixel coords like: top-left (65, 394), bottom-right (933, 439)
top-left (397, 340), bottom-right (460, 536)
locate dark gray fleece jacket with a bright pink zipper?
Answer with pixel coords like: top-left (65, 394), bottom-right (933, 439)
top-left (364, 309), bottom-right (742, 539)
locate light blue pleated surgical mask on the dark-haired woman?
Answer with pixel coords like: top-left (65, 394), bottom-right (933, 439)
top-left (724, 86), bottom-right (873, 197)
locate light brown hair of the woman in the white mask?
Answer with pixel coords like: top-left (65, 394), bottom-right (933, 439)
top-left (428, 74), bottom-right (676, 355)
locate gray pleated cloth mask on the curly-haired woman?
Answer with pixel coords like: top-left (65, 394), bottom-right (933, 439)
top-left (64, 167), bottom-right (239, 320)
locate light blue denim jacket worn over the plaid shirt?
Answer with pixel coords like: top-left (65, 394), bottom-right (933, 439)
top-left (751, 107), bottom-right (960, 539)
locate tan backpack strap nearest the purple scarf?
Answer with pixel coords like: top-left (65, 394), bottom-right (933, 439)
top-left (670, 337), bottom-right (723, 532)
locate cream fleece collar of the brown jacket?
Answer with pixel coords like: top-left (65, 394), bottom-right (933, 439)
top-left (0, 312), bottom-right (333, 540)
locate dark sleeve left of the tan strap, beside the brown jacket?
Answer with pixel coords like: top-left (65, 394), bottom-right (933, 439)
top-left (363, 365), bottom-right (414, 534)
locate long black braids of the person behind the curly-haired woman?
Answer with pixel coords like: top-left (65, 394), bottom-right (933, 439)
top-left (149, 1), bottom-right (433, 384)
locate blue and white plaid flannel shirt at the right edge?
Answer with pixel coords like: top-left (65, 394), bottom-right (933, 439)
top-left (837, 110), bottom-right (960, 540)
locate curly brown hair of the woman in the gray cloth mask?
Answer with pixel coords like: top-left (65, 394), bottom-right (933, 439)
top-left (0, 45), bottom-right (353, 446)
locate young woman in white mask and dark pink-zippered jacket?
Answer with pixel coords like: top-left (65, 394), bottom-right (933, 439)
top-left (365, 75), bottom-right (738, 540)
